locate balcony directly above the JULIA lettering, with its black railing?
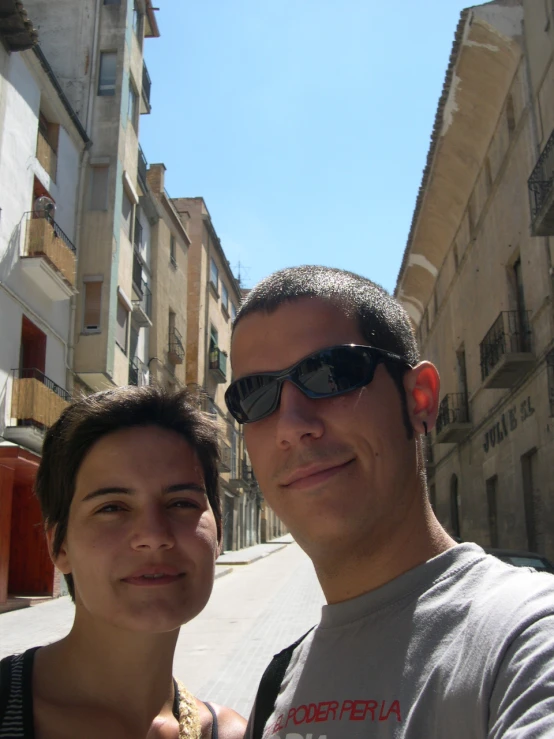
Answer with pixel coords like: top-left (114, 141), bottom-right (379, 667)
top-left (480, 310), bottom-right (535, 388)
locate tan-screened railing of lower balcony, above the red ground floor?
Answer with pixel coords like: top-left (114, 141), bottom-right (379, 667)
top-left (11, 367), bottom-right (71, 428)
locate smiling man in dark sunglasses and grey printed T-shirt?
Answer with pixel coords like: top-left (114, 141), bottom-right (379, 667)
top-left (226, 267), bottom-right (554, 739)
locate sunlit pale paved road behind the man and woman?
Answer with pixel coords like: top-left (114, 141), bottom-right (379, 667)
top-left (0, 544), bottom-right (323, 716)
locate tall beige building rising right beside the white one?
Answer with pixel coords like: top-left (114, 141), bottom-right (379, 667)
top-left (28, 0), bottom-right (159, 392)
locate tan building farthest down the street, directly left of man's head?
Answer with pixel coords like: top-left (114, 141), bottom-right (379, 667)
top-left (173, 197), bottom-right (284, 550)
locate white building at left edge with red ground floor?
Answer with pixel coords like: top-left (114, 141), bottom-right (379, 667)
top-left (0, 1), bottom-right (90, 604)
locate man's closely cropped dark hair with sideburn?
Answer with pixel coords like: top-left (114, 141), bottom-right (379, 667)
top-left (233, 265), bottom-right (419, 439)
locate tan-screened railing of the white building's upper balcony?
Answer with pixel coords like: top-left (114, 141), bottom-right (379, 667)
top-left (22, 213), bottom-right (77, 286)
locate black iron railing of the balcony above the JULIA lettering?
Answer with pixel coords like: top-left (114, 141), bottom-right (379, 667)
top-left (480, 310), bottom-right (531, 380)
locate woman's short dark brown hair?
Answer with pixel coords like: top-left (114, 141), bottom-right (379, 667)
top-left (35, 385), bottom-right (221, 599)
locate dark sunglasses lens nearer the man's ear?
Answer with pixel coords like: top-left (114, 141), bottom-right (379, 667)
top-left (297, 346), bottom-right (372, 397)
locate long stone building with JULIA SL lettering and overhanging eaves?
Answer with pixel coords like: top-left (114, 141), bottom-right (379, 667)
top-left (396, 0), bottom-right (554, 558)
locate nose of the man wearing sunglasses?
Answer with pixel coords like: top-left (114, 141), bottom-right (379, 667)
top-left (275, 380), bottom-right (324, 448)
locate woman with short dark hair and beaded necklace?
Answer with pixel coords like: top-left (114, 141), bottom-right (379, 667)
top-left (0, 386), bottom-right (245, 739)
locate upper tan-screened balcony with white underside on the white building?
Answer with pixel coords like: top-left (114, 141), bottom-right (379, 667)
top-left (21, 214), bottom-right (77, 301)
